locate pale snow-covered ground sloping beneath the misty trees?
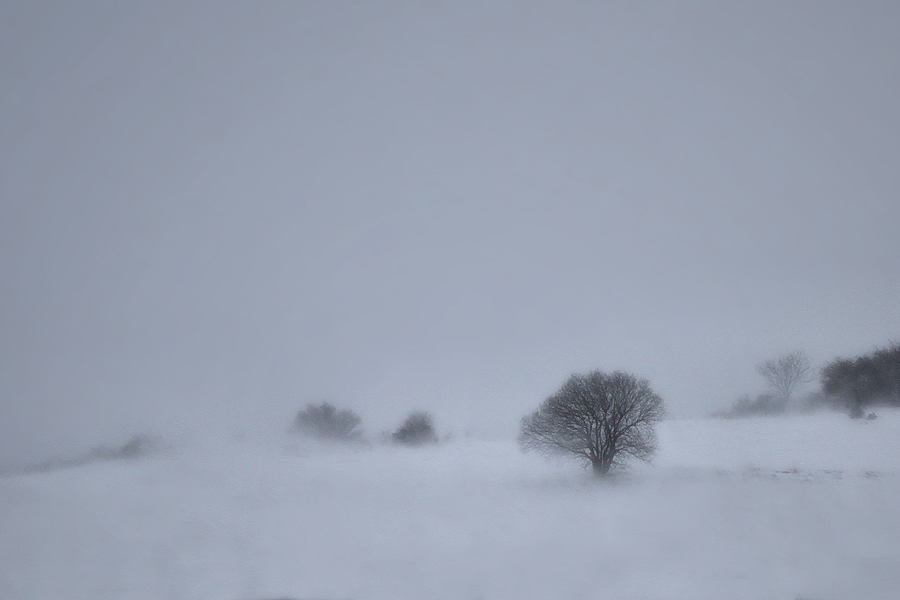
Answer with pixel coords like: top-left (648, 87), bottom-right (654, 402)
top-left (0, 411), bottom-right (900, 600)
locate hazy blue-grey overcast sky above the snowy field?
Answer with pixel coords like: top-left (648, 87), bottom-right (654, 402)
top-left (0, 1), bottom-right (900, 462)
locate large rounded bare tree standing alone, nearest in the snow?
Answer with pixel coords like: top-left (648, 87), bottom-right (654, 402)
top-left (519, 371), bottom-right (665, 476)
